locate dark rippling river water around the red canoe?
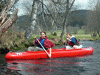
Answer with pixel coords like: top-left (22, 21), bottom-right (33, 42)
top-left (0, 41), bottom-right (100, 75)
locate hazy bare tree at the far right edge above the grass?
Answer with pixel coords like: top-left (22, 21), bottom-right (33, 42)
top-left (87, 0), bottom-right (100, 37)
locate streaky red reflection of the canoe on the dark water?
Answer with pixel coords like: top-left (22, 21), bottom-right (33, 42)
top-left (7, 58), bottom-right (85, 75)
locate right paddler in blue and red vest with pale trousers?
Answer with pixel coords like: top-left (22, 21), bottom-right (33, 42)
top-left (66, 33), bottom-right (83, 49)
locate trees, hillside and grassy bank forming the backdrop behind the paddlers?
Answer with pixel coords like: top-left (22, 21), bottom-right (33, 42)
top-left (0, 0), bottom-right (100, 50)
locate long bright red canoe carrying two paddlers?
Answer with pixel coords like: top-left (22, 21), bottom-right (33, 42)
top-left (5, 47), bottom-right (94, 60)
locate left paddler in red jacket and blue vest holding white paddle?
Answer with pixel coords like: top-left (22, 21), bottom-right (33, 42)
top-left (28, 31), bottom-right (55, 51)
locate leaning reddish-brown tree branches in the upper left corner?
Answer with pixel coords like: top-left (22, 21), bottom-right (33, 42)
top-left (0, 0), bottom-right (18, 38)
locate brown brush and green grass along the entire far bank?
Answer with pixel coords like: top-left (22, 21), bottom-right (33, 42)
top-left (0, 29), bottom-right (100, 51)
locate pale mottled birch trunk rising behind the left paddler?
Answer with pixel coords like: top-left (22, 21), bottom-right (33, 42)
top-left (25, 0), bottom-right (38, 41)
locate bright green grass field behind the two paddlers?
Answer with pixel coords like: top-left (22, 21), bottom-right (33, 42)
top-left (30, 29), bottom-right (100, 41)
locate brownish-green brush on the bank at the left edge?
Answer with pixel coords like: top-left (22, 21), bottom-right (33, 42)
top-left (0, 30), bottom-right (28, 49)
